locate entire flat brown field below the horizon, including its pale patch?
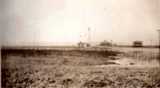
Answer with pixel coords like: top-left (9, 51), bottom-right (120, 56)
top-left (1, 48), bottom-right (160, 88)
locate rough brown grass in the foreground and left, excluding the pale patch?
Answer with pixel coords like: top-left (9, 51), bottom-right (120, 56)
top-left (2, 47), bottom-right (160, 88)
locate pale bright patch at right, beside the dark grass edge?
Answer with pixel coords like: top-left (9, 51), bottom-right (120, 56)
top-left (113, 48), bottom-right (160, 67)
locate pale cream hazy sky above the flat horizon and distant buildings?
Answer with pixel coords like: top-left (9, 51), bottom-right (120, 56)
top-left (1, 0), bottom-right (160, 45)
